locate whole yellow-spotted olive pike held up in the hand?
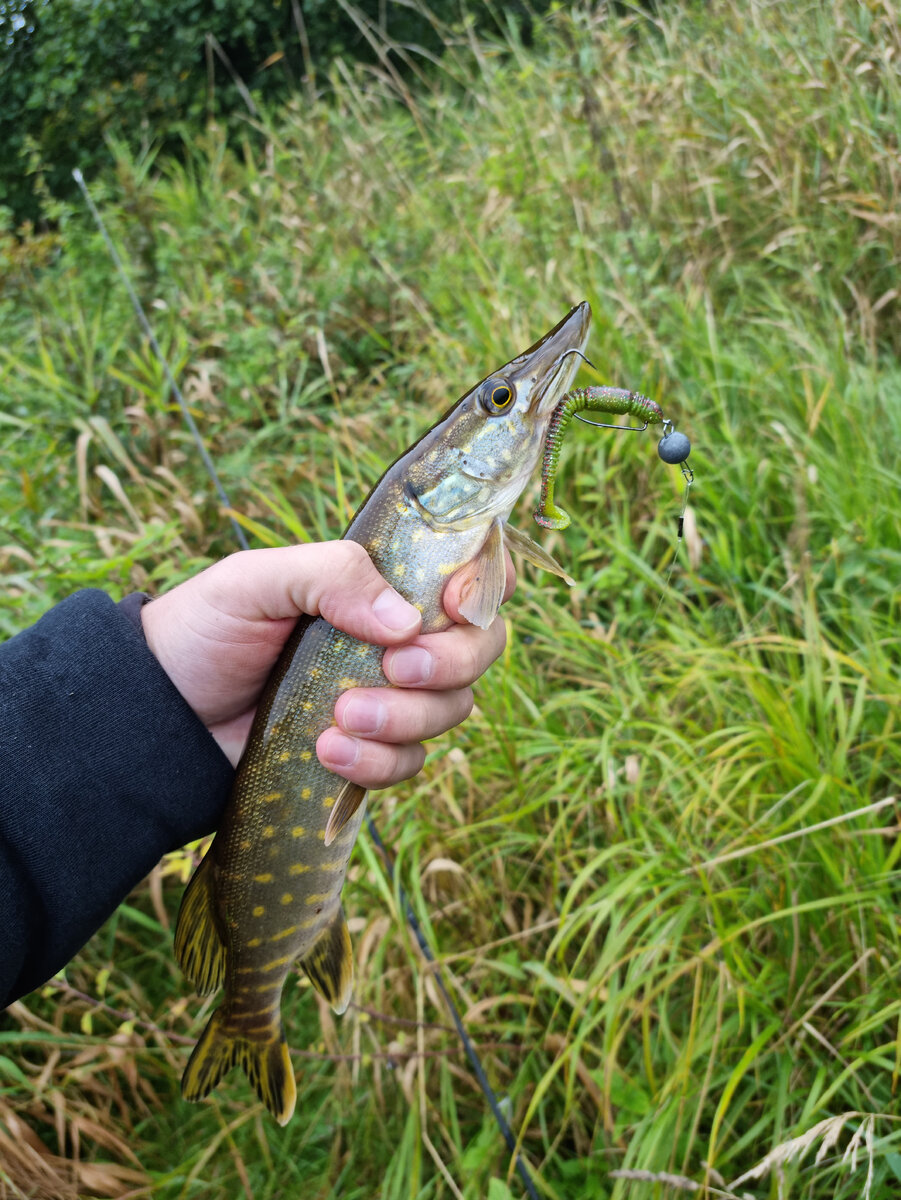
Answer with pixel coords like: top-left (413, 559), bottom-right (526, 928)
top-left (175, 304), bottom-right (591, 1124)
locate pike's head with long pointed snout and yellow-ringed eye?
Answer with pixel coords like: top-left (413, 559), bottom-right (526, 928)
top-left (396, 302), bottom-right (591, 530)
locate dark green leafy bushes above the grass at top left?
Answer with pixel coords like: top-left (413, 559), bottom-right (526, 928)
top-left (0, 0), bottom-right (542, 224)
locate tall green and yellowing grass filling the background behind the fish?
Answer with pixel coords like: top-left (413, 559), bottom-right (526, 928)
top-left (0, 0), bottom-right (901, 1200)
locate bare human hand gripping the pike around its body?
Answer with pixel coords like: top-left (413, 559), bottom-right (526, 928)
top-left (142, 541), bottom-right (516, 787)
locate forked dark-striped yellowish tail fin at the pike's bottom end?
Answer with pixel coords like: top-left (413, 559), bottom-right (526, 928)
top-left (181, 1008), bottom-right (298, 1126)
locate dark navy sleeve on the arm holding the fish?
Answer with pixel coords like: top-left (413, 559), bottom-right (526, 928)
top-left (0, 592), bottom-right (233, 1008)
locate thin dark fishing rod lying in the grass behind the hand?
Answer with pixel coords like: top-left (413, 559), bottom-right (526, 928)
top-left (72, 168), bottom-right (539, 1200)
